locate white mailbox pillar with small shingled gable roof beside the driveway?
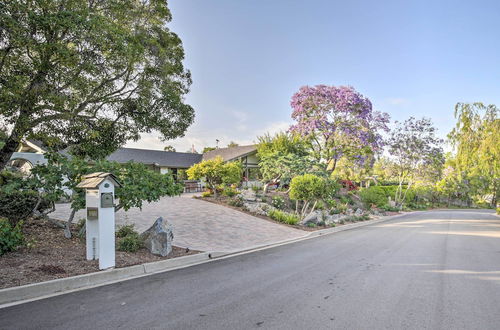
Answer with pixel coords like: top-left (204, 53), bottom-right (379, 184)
top-left (77, 172), bottom-right (121, 269)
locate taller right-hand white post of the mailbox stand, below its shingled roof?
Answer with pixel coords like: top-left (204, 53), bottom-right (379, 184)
top-left (98, 179), bottom-right (115, 269)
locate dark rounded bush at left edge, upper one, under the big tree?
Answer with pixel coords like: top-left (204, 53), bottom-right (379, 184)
top-left (0, 190), bottom-right (42, 225)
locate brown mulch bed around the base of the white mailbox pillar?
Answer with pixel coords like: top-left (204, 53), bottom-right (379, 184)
top-left (0, 220), bottom-right (199, 289)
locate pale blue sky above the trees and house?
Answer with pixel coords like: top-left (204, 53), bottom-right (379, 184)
top-left (127, 0), bottom-right (500, 152)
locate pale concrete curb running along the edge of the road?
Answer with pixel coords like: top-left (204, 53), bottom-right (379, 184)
top-left (0, 211), bottom-right (412, 309)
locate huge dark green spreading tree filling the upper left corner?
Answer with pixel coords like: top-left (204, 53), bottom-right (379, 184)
top-left (0, 0), bottom-right (194, 169)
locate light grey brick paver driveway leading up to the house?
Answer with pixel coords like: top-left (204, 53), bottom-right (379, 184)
top-left (50, 196), bottom-right (307, 251)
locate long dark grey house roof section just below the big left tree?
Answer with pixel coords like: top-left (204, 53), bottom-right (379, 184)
top-left (107, 148), bottom-right (203, 168)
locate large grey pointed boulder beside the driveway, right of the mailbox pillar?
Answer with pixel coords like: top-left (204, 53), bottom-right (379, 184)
top-left (141, 217), bottom-right (174, 257)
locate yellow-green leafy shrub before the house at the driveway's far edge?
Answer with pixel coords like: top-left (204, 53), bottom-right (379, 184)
top-left (186, 157), bottom-right (243, 195)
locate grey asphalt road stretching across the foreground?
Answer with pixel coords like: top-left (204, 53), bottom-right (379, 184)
top-left (0, 211), bottom-right (500, 330)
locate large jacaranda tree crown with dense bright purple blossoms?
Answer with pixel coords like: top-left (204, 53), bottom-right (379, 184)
top-left (290, 85), bottom-right (389, 172)
